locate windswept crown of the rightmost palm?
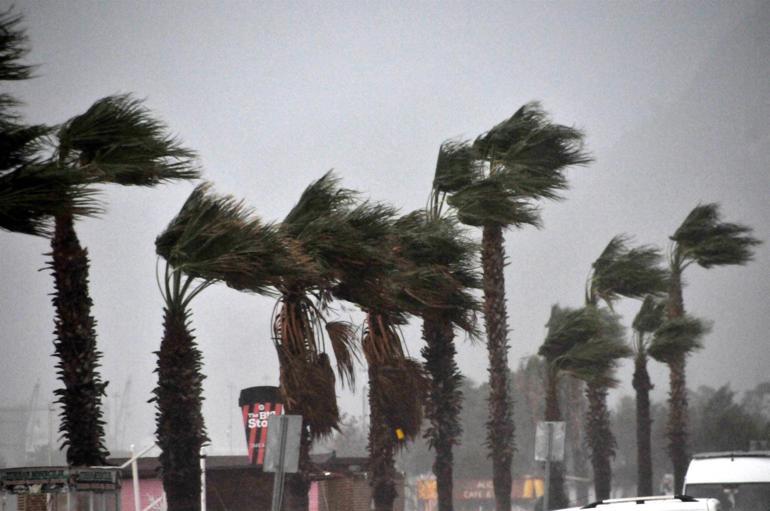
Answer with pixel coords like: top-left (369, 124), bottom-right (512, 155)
top-left (671, 203), bottom-right (761, 268)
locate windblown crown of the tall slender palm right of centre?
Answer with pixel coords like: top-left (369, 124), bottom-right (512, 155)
top-left (433, 102), bottom-right (591, 227)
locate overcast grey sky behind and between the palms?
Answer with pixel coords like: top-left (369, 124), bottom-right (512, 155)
top-left (0, 1), bottom-right (770, 453)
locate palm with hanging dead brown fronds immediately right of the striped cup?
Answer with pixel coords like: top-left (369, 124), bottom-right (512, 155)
top-left (273, 172), bottom-right (394, 511)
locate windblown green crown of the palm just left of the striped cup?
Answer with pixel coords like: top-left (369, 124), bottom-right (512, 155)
top-left (155, 183), bottom-right (287, 293)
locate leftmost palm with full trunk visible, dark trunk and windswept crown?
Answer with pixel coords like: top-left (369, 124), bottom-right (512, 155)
top-left (49, 95), bottom-right (198, 465)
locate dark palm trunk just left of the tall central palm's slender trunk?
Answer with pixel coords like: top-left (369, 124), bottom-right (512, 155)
top-left (422, 315), bottom-right (462, 511)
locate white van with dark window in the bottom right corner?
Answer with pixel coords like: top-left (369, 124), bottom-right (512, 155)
top-left (683, 451), bottom-right (770, 511)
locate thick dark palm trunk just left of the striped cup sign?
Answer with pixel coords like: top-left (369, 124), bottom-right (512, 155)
top-left (153, 307), bottom-right (207, 511)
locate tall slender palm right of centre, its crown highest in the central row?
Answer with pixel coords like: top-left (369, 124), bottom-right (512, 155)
top-left (434, 103), bottom-right (591, 511)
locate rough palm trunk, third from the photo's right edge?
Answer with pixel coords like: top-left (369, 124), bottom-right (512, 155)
top-left (586, 383), bottom-right (616, 500)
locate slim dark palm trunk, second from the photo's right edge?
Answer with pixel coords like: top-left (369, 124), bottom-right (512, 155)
top-left (632, 352), bottom-right (653, 495)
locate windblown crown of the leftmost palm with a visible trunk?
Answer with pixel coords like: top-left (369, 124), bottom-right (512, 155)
top-left (58, 94), bottom-right (199, 186)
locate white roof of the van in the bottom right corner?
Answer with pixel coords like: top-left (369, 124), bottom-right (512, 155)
top-left (684, 451), bottom-right (770, 486)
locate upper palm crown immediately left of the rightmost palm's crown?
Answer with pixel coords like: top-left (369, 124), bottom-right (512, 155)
top-left (588, 235), bottom-right (668, 307)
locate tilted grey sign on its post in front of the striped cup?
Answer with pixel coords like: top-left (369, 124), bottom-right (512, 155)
top-left (264, 415), bottom-right (302, 511)
